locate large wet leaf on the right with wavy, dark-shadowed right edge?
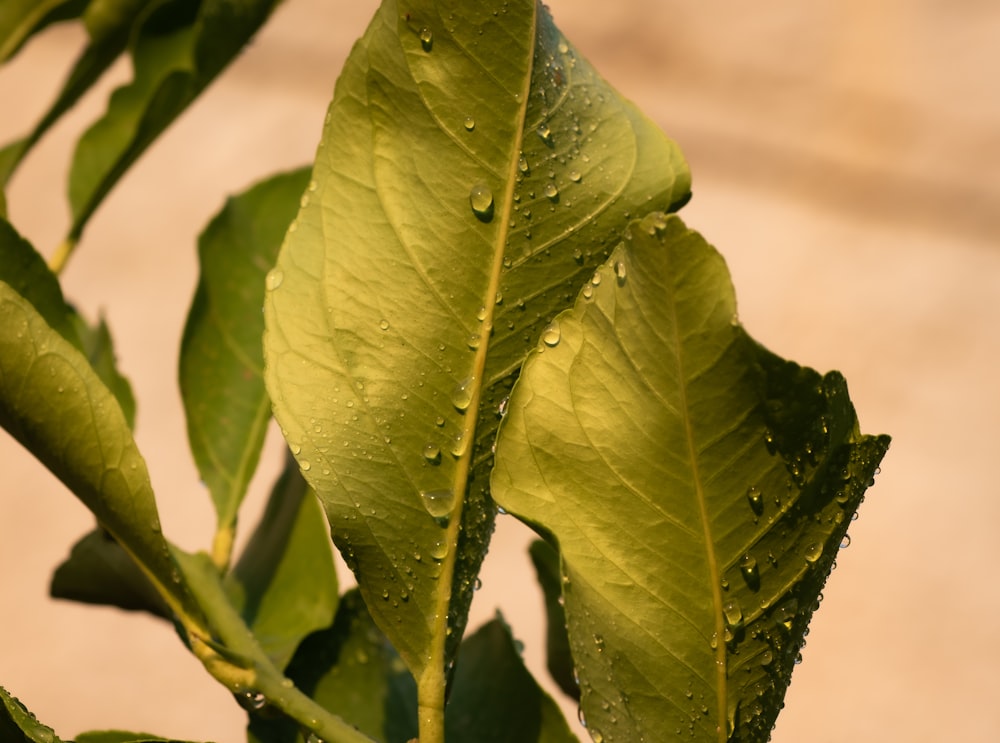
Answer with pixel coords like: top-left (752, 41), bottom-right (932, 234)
top-left (493, 214), bottom-right (888, 741)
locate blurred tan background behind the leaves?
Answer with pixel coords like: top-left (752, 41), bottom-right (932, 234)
top-left (0, 0), bottom-right (1000, 743)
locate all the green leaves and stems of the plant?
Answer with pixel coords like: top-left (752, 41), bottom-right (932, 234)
top-left (0, 0), bottom-right (888, 743)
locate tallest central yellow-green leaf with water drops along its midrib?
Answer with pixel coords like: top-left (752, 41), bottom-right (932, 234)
top-left (265, 0), bottom-right (689, 708)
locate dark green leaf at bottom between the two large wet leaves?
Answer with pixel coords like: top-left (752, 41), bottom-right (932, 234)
top-left (446, 615), bottom-right (578, 743)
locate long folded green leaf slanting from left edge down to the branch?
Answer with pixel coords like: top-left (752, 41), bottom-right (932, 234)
top-left (0, 282), bottom-right (200, 621)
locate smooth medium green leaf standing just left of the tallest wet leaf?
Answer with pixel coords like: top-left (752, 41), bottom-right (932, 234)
top-left (180, 169), bottom-right (309, 530)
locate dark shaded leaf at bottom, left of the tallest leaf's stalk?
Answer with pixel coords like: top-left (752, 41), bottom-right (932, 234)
top-left (249, 589), bottom-right (417, 743)
